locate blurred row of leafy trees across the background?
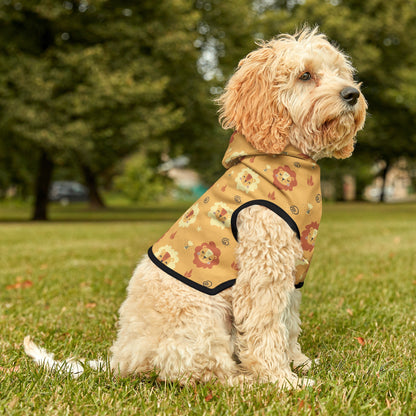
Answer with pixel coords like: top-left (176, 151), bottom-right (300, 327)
top-left (0, 0), bottom-right (416, 219)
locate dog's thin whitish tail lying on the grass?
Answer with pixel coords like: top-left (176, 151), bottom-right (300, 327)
top-left (23, 335), bottom-right (107, 378)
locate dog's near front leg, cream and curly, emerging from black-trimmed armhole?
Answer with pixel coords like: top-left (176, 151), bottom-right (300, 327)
top-left (232, 206), bottom-right (312, 387)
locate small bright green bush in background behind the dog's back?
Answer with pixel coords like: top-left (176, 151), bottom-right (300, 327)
top-left (114, 153), bottom-right (172, 202)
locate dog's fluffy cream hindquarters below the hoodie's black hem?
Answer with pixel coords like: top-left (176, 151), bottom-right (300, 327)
top-left (111, 259), bottom-right (237, 383)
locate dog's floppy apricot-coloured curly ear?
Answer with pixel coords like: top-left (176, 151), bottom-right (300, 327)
top-left (217, 44), bottom-right (292, 153)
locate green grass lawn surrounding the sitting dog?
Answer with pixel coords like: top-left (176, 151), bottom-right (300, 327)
top-left (0, 204), bottom-right (416, 415)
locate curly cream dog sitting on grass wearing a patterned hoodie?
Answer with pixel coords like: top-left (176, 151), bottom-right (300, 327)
top-left (25, 28), bottom-right (367, 388)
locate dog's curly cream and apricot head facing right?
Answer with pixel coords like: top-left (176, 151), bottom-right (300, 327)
top-left (218, 28), bottom-right (367, 159)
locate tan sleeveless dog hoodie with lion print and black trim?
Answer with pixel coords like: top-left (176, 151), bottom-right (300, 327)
top-left (149, 133), bottom-right (322, 295)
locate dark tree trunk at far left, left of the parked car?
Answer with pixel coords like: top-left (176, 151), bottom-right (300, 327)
top-left (32, 150), bottom-right (54, 221)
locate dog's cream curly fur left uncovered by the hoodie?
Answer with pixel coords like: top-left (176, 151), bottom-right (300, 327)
top-left (27, 29), bottom-right (367, 387)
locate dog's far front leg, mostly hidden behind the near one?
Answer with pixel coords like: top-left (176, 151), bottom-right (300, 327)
top-left (285, 290), bottom-right (316, 373)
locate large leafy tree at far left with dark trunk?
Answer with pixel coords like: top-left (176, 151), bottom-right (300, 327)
top-left (0, 0), bottom-right (196, 219)
